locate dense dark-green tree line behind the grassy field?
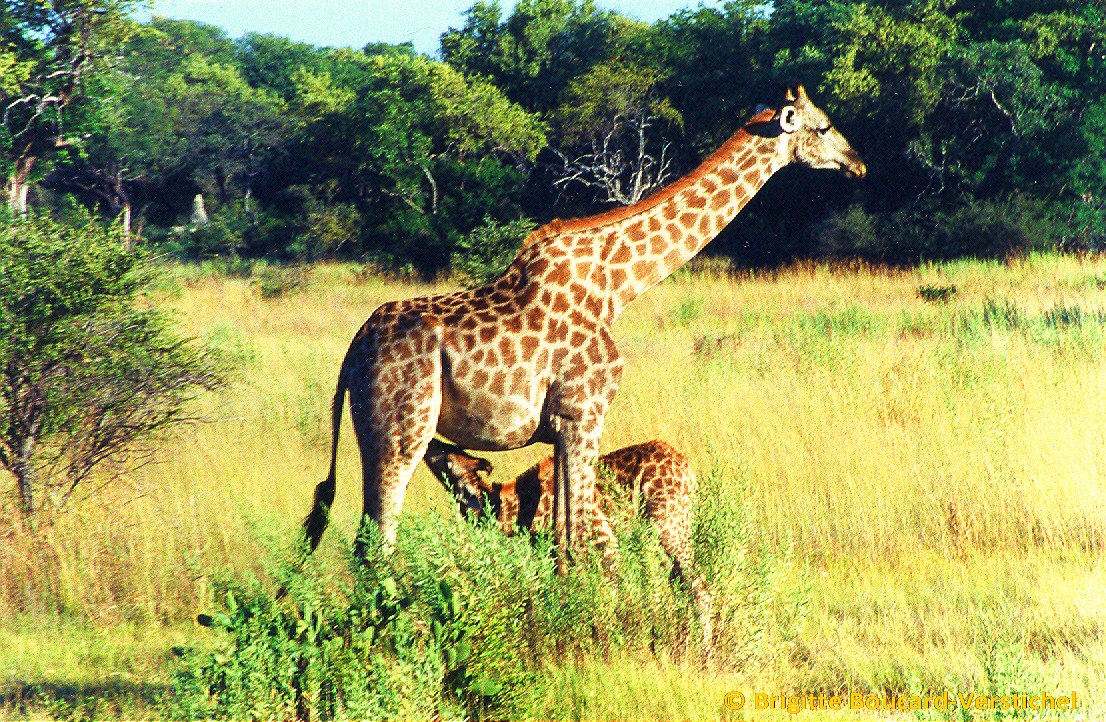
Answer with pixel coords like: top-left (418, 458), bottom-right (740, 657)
top-left (0, 0), bottom-right (1106, 269)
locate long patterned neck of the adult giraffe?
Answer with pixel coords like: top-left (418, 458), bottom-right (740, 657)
top-left (606, 118), bottom-right (790, 316)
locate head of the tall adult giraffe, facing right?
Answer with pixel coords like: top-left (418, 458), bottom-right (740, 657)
top-left (775, 85), bottom-right (867, 178)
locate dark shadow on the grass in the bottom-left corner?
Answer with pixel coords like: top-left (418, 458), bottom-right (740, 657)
top-left (0, 679), bottom-right (169, 720)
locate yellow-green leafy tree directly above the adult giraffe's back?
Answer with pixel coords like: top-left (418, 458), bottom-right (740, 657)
top-left (292, 52), bottom-right (545, 274)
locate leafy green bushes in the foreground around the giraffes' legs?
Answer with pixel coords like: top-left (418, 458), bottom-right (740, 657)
top-left (170, 464), bottom-right (804, 719)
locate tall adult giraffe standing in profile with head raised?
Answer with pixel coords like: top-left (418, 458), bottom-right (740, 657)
top-left (304, 85), bottom-right (865, 568)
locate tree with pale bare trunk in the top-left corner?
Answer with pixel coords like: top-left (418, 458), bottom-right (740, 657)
top-left (0, 0), bottom-right (138, 212)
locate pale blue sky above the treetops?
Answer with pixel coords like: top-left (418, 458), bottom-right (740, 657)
top-left (138, 0), bottom-right (721, 53)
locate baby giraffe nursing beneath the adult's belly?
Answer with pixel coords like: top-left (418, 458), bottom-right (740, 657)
top-left (424, 439), bottom-right (711, 646)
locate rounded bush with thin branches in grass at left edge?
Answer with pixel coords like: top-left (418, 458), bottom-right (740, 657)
top-left (0, 217), bottom-right (222, 520)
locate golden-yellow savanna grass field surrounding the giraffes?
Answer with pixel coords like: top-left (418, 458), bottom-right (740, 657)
top-left (0, 257), bottom-right (1106, 719)
